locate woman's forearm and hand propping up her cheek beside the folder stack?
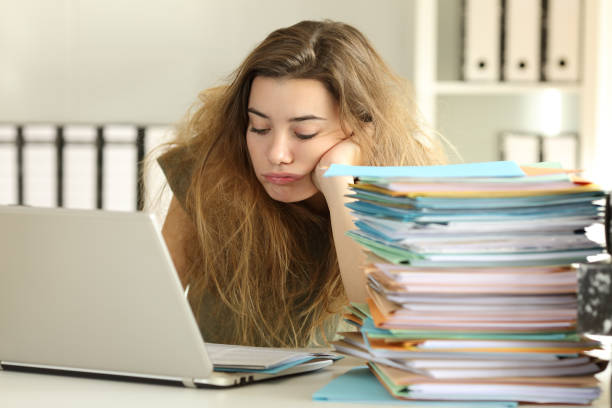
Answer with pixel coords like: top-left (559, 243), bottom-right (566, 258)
top-left (313, 139), bottom-right (367, 302)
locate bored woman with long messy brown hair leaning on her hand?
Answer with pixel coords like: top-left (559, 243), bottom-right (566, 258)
top-left (159, 21), bottom-right (444, 347)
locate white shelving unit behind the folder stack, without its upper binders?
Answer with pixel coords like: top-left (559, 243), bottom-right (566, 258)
top-left (412, 0), bottom-right (608, 174)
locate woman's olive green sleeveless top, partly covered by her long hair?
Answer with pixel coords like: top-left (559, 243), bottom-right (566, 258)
top-left (157, 148), bottom-right (351, 344)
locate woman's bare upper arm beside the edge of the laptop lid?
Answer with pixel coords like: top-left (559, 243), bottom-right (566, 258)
top-left (162, 197), bottom-right (194, 287)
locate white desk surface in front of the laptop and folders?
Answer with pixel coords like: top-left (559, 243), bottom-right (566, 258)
top-left (0, 358), bottom-right (610, 408)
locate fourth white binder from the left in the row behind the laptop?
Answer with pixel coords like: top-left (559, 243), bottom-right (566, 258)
top-left (102, 125), bottom-right (138, 211)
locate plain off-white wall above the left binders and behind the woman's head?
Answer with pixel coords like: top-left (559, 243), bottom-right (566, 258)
top-left (0, 0), bottom-right (413, 124)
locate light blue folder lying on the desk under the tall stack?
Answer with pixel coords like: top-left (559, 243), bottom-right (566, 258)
top-left (312, 366), bottom-right (518, 408)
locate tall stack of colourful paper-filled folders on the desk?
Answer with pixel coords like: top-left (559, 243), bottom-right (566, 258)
top-left (326, 162), bottom-right (607, 404)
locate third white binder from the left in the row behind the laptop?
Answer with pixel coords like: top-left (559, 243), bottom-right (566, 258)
top-left (63, 125), bottom-right (97, 209)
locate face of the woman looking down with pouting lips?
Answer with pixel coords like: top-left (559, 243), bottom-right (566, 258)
top-left (246, 76), bottom-right (347, 203)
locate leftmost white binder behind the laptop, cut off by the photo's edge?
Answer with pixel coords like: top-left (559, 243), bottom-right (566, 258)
top-left (0, 125), bottom-right (18, 205)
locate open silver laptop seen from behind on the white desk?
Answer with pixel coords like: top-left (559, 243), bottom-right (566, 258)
top-left (0, 206), bottom-right (331, 387)
